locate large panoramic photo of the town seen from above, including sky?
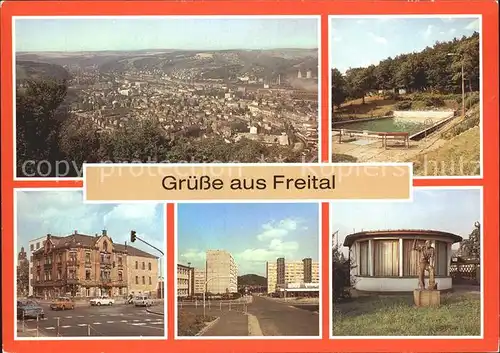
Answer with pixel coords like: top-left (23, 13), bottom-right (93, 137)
top-left (14, 16), bottom-right (319, 177)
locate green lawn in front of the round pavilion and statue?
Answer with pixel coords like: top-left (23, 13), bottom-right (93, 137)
top-left (333, 293), bottom-right (481, 336)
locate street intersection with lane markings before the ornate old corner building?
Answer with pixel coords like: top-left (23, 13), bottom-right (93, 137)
top-left (17, 304), bottom-right (165, 337)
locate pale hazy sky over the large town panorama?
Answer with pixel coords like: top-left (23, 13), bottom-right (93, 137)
top-left (15, 17), bottom-right (318, 52)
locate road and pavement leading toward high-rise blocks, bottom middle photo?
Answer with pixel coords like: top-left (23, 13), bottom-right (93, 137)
top-left (178, 296), bottom-right (320, 337)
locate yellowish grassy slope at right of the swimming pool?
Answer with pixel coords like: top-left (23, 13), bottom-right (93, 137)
top-left (413, 126), bottom-right (481, 176)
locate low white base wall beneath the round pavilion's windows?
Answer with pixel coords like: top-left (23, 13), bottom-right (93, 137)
top-left (354, 276), bottom-right (451, 292)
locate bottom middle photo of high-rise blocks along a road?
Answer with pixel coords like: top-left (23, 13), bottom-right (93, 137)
top-left (176, 203), bottom-right (321, 338)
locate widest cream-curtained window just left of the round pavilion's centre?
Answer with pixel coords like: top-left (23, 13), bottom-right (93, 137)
top-left (373, 240), bottom-right (399, 277)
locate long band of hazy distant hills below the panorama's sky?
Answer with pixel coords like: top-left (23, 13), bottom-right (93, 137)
top-left (17, 48), bottom-right (318, 78)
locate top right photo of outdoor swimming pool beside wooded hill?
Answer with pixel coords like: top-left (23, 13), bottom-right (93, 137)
top-left (330, 16), bottom-right (481, 177)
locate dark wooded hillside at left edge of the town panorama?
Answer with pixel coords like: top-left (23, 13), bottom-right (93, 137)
top-left (16, 60), bottom-right (70, 83)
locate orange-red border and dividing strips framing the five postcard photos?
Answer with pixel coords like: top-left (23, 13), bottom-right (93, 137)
top-left (0, 0), bottom-right (499, 353)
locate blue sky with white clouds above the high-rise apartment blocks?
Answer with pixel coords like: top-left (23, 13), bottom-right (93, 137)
top-left (177, 203), bottom-right (319, 277)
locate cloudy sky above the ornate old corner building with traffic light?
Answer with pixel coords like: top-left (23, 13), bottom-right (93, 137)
top-left (16, 190), bottom-right (166, 276)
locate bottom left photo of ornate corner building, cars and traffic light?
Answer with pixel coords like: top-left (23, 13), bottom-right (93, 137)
top-left (15, 189), bottom-right (167, 339)
